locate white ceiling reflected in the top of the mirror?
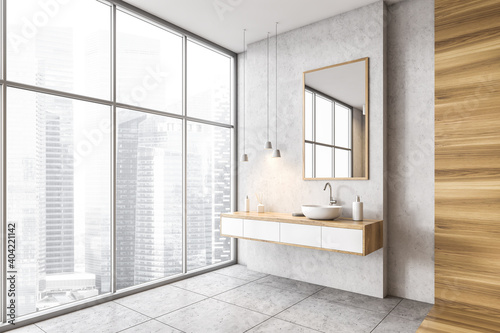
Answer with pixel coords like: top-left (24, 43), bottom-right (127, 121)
top-left (306, 61), bottom-right (366, 110)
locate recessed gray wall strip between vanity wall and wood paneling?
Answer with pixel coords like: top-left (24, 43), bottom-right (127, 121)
top-left (387, 0), bottom-right (434, 303)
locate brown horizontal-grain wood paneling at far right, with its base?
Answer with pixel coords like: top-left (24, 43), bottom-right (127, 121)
top-left (419, 0), bottom-right (500, 332)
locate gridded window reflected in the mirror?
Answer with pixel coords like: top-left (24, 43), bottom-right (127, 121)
top-left (304, 87), bottom-right (353, 178)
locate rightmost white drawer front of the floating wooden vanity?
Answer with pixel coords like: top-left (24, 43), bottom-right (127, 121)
top-left (321, 227), bottom-right (363, 253)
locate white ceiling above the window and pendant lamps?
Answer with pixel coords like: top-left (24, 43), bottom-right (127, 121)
top-left (121, 0), bottom-right (398, 53)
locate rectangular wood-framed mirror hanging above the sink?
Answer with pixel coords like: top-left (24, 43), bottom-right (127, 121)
top-left (302, 58), bottom-right (369, 180)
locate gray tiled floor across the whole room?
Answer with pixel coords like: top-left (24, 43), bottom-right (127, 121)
top-left (11, 265), bottom-right (432, 333)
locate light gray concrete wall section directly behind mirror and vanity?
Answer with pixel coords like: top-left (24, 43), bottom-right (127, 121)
top-left (238, 1), bottom-right (387, 297)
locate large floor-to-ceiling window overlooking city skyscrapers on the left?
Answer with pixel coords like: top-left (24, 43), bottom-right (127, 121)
top-left (0, 0), bottom-right (235, 322)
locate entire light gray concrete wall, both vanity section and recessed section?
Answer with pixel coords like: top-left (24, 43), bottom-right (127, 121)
top-left (238, 0), bottom-right (434, 303)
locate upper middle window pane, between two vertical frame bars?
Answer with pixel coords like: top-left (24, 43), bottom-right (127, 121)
top-left (116, 11), bottom-right (182, 114)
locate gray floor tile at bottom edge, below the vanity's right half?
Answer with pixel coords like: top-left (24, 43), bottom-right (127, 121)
top-left (277, 297), bottom-right (385, 333)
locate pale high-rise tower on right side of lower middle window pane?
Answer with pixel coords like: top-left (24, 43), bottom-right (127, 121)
top-left (134, 117), bottom-right (182, 284)
